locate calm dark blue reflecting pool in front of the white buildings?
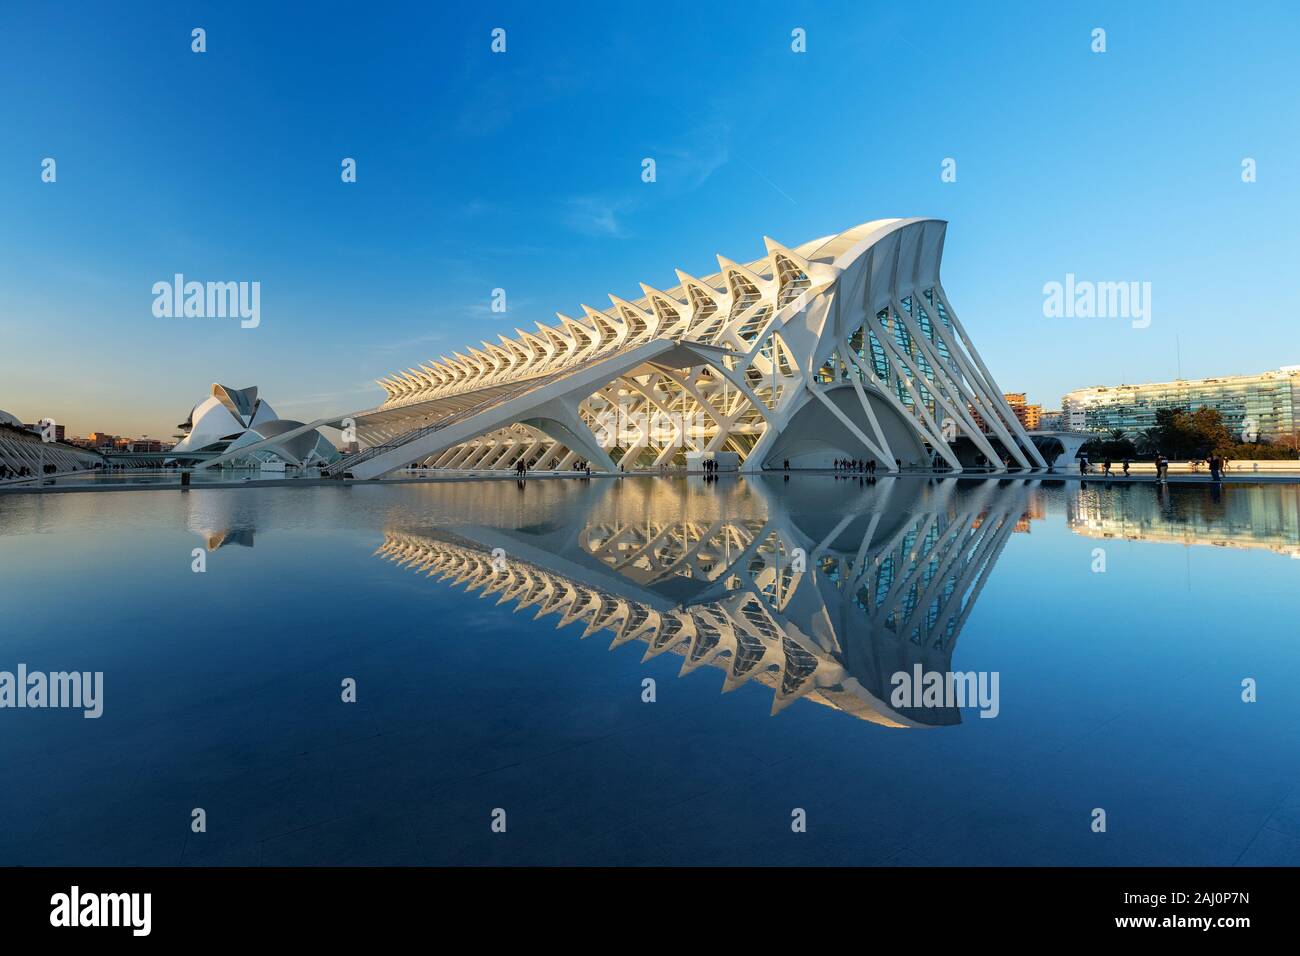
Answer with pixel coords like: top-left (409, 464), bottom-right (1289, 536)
top-left (0, 475), bottom-right (1300, 865)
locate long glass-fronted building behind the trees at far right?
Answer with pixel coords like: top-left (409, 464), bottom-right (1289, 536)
top-left (1061, 365), bottom-right (1300, 441)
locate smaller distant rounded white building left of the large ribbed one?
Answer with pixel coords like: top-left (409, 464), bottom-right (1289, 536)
top-left (168, 384), bottom-right (339, 466)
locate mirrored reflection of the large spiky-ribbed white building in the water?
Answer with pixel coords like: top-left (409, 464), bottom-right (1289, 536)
top-left (376, 479), bottom-right (1030, 727)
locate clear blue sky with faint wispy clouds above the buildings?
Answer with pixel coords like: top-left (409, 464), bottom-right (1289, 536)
top-left (0, 1), bottom-right (1300, 436)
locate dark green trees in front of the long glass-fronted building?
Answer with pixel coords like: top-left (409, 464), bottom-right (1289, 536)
top-left (1083, 407), bottom-right (1296, 460)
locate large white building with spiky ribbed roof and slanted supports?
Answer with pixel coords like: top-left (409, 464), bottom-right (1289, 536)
top-left (200, 219), bottom-right (1048, 479)
